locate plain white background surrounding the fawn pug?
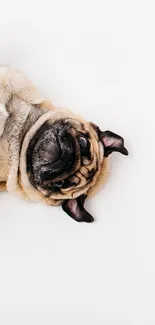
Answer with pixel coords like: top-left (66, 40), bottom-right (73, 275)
top-left (0, 0), bottom-right (155, 325)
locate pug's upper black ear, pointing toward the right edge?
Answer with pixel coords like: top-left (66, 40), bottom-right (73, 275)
top-left (100, 131), bottom-right (128, 157)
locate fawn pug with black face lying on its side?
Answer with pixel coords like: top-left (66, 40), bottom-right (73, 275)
top-left (0, 67), bottom-right (128, 222)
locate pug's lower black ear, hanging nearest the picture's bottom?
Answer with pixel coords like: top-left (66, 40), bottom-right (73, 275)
top-left (62, 194), bottom-right (94, 222)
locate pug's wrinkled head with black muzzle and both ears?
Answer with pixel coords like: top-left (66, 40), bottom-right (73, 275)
top-left (27, 118), bottom-right (128, 222)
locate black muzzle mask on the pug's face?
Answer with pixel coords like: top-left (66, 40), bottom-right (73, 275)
top-left (27, 122), bottom-right (76, 188)
